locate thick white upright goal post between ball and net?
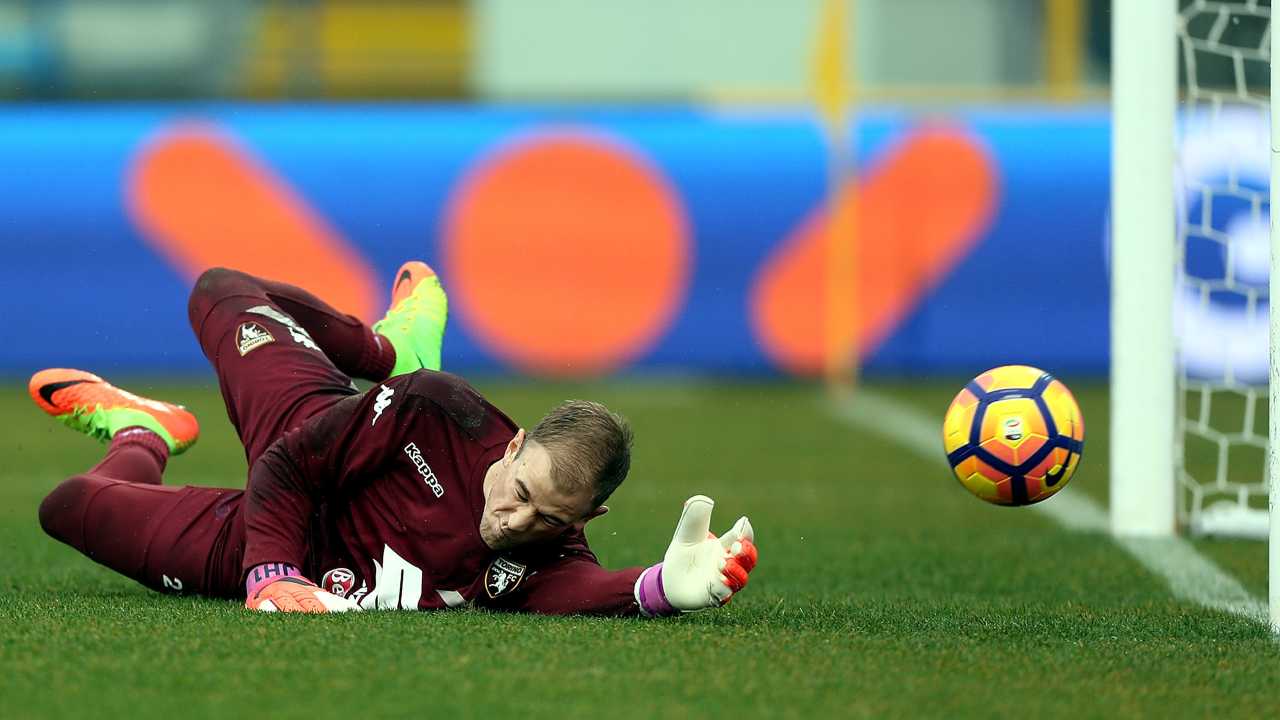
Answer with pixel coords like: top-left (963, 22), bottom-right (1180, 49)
top-left (1111, 0), bottom-right (1178, 536)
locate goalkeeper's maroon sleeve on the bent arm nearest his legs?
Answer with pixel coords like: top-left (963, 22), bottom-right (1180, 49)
top-left (242, 375), bottom-right (422, 571)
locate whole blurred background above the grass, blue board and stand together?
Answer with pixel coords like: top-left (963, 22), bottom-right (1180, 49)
top-left (0, 0), bottom-right (1136, 377)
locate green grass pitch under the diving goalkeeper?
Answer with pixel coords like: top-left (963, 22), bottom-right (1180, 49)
top-left (0, 380), bottom-right (1280, 719)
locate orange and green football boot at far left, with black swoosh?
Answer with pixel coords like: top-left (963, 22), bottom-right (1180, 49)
top-left (27, 368), bottom-right (200, 455)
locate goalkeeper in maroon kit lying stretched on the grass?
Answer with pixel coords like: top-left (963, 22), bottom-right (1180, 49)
top-left (29, 261), bottom-right (755, 615)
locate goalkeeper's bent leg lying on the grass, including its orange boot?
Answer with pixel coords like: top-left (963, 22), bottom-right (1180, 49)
top-left (29, 384), bottom-right (244, 597)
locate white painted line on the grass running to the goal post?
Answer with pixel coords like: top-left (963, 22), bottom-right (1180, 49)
top-left (829, 388), bottom-right (1267, 624)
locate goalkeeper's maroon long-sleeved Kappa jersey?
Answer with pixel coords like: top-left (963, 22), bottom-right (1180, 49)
top-left (243, 370), bottom-right (641, 615)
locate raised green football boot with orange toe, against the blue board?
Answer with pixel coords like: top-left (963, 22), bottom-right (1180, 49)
top-left (374, 260), bottom-right (449, 378)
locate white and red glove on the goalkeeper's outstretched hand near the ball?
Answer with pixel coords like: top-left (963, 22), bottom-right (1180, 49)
top-left (635, 495), bottom-right (758, 615)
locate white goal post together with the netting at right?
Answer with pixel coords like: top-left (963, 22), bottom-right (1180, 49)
top-left (1110, 0), bottom-right (1280, 632)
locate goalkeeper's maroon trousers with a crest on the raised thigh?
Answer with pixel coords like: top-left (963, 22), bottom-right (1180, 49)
top-left (40, 270), bottom-right (367, 598)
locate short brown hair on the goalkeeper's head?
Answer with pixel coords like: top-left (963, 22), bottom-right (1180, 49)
top-left (529, 400), bottom-right (634, 507)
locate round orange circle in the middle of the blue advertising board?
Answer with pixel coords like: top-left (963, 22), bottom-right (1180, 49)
top-left (443, 131), bottom-right (691, 375)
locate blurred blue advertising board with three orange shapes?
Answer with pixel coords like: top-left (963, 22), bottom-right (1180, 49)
top-left (0, 105), bottom-right (1110, 377)
